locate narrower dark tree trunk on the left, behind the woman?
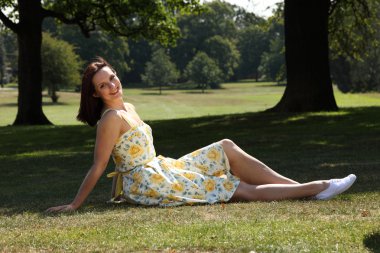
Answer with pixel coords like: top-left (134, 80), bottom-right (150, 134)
top-left (13, 0), bottom-right (51, 125)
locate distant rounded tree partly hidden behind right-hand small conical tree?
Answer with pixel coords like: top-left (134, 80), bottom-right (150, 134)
top-left (203, 35), bottom-right (240, 81)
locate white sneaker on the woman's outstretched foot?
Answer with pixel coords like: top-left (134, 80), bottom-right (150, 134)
top-left (315, 174), bottom-right (356, 200)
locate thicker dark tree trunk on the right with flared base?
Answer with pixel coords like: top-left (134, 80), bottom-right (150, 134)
top-left (270, 0), bottom-right (338, 112)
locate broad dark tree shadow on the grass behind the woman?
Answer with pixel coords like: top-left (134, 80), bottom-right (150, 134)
top-left (0, 107), bottom-right (380, 214)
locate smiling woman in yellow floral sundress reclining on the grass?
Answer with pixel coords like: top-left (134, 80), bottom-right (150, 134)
top-left (47, 58), bottom-right (356, 212)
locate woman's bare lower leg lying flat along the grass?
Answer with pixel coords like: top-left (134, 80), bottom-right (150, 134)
top-left (231, 180), bottom-right (329, 201)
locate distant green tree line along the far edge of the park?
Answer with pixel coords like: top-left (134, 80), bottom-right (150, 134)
top-left (0, 0), bottom-right (380, 105)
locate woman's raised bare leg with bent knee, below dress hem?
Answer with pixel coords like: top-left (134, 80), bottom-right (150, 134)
top-left (220, 139), bottom-right (299, 185)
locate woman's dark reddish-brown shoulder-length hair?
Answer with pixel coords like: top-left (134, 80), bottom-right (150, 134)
top-left (77, 57), bottom-right (116, 126)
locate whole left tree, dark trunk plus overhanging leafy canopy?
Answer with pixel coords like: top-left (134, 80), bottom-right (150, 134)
top-left (0, 0), bottom-right (201, 125)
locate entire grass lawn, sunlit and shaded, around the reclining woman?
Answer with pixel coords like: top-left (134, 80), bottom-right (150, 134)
top-left (0, 83), bottom-right (380, 252)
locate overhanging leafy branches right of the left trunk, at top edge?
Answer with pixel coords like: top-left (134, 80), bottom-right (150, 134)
top-left (43, 0), bottom-right (202, 45)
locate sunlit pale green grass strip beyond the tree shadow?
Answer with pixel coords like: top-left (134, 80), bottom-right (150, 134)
top-left (0, 81), bottom-right (380, 126)
